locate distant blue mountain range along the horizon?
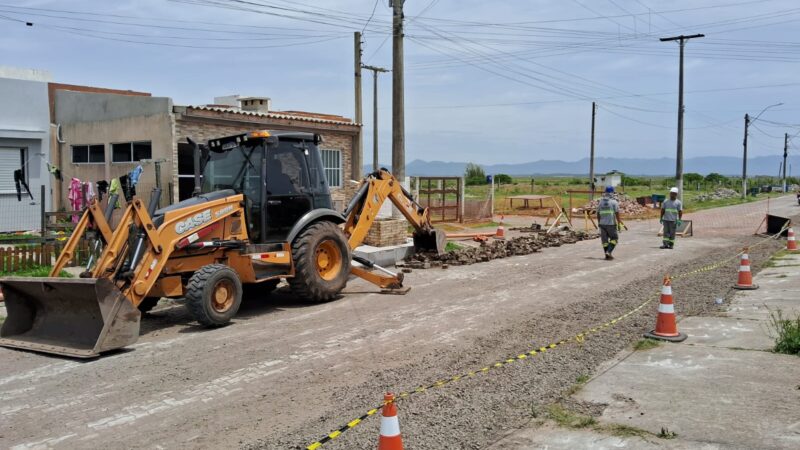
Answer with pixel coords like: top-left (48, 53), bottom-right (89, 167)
top-left (364, 155), bottom-right (800, 176)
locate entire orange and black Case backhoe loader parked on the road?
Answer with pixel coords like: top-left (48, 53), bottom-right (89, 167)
top-left (0, 131), bottom-right (445, 358)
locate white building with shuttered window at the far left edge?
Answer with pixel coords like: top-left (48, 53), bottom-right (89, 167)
top-left (0, 66), bottom-right (52, 232)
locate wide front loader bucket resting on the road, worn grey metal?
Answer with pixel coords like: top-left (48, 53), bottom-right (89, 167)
top-left (0, 277), bottom-right (141, 358)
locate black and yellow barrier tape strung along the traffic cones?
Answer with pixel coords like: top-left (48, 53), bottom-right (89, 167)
top-left (306, 225), bottom-right (788, 450)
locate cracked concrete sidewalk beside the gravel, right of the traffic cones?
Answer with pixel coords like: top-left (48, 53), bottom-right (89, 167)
top-left (491, 254), bottom-right (800, 450)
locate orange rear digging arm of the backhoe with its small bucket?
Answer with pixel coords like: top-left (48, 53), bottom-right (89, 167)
top-left (344, 169), bottom-right (447, 292)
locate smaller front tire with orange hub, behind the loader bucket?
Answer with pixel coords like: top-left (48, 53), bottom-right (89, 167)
top-left (186, 264), bottom-right (242, 327)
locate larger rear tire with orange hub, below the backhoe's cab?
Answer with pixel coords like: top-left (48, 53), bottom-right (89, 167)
top-left (289, 221), bottom-right (351, 302)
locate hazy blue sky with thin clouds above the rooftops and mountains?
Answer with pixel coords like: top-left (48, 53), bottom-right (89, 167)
top-left (0, 0), bottom-right (800, 164)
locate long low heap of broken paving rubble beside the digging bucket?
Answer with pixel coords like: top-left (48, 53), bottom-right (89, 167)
top-left (406, 230), bottom-right (597, 269)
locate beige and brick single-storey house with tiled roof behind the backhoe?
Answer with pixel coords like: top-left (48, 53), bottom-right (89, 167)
top-left (53, 91), bottom-right (361, 213)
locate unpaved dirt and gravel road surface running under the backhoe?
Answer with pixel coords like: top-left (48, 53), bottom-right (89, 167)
top-left (0, 197), bottom-right (800, 449)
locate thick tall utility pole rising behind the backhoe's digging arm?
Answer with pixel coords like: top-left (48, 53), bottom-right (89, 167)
top-left (390, 0), bottom-right (406, 183)
